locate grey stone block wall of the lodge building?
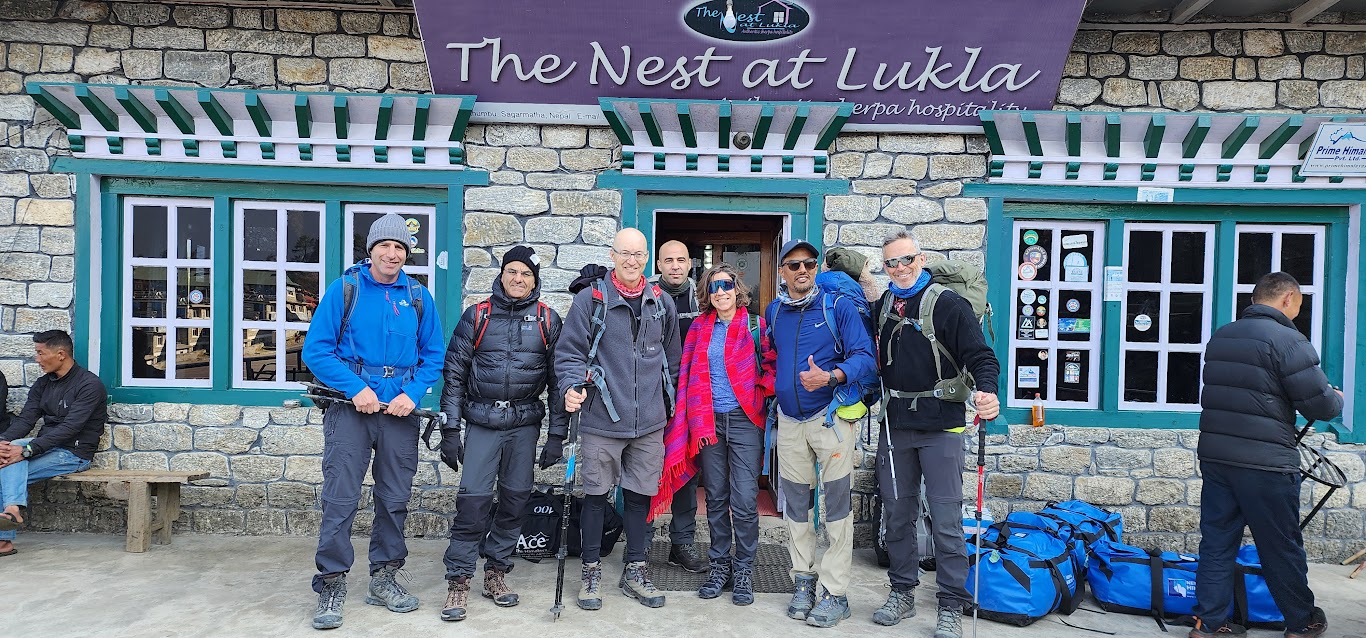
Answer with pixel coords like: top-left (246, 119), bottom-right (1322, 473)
top-left (0, 0), bottom-right (1366, 559)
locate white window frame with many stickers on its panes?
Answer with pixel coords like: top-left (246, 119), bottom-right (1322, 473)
top-left (1005, 220), bottom-right (1105, 410)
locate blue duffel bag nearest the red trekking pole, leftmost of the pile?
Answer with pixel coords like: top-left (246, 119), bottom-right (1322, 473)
top-left (966, 527), bottom-right (1085, 627)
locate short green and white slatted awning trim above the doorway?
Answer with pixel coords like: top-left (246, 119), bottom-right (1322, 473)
top-left (598, 97), bottom-right (854, 178)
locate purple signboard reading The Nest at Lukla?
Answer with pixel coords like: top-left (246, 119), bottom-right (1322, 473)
top-left (415, 0), bottom-right (1085, 130)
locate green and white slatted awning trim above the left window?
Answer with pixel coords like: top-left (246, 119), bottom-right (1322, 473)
top-left (26, 82), bottom-right (474, 169)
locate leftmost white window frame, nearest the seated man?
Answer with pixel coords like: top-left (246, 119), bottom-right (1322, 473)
top-left (119, 197), bottom-right (215, 388)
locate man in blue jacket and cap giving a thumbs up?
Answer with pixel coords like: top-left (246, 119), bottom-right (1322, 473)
top-left (765, 239), bottom-right (877, 627)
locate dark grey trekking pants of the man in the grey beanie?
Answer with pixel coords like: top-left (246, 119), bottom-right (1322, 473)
top-left (313, 404), bottom-right (419, 592)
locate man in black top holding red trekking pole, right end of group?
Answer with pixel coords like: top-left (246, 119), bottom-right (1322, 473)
top-left (873, 231), bottom-right (1000, 638)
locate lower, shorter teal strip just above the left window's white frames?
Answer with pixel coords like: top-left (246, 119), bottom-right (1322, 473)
top-left (104, 178), bottom-right (448, 204)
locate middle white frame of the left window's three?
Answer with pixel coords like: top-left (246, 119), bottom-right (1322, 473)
top-left (232, 199), bottom-right (328, 389)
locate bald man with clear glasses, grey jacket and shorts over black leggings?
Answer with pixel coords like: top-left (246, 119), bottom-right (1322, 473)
top-left (555, 228), bottom-right (682, 611)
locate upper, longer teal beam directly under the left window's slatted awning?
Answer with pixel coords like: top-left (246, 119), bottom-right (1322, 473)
top-left (52, 157), bottom-right (489, 187)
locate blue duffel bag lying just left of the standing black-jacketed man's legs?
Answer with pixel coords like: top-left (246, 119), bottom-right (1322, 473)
top-left (1086, 538), bottom-right (1199, 631)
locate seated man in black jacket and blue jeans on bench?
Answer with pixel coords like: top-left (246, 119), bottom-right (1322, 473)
top-left (0, 331), bottom-right (108, 556)
